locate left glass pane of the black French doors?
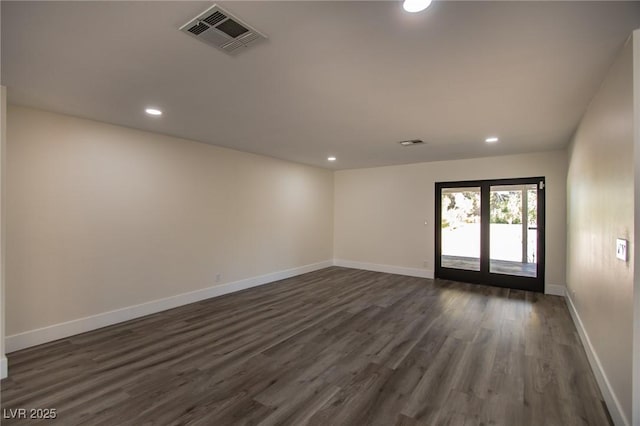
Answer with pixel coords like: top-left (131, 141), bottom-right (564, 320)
top-left (440, 187), bottom-right (480, 271)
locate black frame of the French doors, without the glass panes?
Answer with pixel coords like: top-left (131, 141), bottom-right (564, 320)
top-left (434, 177), bottom-right (546, 292)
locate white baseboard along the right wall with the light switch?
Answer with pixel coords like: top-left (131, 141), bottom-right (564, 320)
top-left (565, 291), bottom-right (629, 426)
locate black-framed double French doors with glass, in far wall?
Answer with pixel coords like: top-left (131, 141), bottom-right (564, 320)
top-left (435, 177), bottom-right (545, 292)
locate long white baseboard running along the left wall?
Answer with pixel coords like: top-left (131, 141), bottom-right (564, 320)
top-left (5, 260), bottom-right (333, 352)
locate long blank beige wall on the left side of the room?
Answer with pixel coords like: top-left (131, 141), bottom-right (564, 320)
top-left (6, 106), bottom-right (333, 335)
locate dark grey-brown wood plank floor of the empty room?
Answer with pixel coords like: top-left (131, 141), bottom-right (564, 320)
top-left (1, 267), bottom-right (610, 426)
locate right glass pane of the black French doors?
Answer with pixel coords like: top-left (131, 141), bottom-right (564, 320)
top-left (489, 184), bottom-right (538, 278)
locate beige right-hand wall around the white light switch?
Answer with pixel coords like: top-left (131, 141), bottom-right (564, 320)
top-left (567, 38), bottom-right (634, 420)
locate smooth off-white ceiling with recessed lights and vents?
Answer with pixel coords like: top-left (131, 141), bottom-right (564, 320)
top-left (1, 1), bottom-right (640, 169)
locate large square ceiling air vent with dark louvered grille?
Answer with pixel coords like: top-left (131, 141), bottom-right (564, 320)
top-left (180, 4), bottom-right (267, 54)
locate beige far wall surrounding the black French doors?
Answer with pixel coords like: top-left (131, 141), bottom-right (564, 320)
top-left (334, 150), bottom-right (566, 285)
